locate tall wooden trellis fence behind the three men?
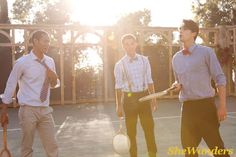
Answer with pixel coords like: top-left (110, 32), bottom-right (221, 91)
top-left (0, 25), bottom-right (236, 104)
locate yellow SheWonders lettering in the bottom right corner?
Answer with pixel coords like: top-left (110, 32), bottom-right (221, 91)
top-left (167, 146), bottom-right (234, 156)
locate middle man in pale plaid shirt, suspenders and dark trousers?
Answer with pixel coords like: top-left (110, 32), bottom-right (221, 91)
top-left (114, 34), bottom-right (157, 157)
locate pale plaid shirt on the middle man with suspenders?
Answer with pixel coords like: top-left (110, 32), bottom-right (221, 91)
top-left (114, 54), bottom-right (153, 92)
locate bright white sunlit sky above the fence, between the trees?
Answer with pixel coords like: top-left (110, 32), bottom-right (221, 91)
top-left (8, 0), bottom-right (194, 27)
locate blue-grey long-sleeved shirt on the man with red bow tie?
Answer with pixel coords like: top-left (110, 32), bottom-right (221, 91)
top-left (172, 44), bottom-right (226, 101)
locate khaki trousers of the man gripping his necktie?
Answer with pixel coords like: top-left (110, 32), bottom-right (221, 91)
top-left (18, 105), bottom-right (58, 157)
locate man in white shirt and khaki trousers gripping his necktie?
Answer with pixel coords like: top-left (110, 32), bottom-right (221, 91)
top-left (1, 30), bottom-right (60, 157)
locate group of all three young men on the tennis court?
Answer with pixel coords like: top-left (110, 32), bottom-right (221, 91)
top-left (1, 20), bottom-right (229, 157)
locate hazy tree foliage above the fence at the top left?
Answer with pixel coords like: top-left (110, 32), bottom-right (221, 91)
top-left (13, 0), bottom-right (71, 24)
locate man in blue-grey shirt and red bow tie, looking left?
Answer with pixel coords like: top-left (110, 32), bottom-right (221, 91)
top-left (172, 20), bottom-right (230, 157)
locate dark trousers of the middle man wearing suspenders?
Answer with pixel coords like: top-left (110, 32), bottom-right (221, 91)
top-left (124, 92), bottom-right (157, 157)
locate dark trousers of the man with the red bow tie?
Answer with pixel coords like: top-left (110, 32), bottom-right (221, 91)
top-left (181, 98), bottom-right (229, 157)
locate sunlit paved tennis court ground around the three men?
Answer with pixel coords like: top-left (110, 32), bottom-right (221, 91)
top-left (0, 97), bottom-right (236, 157)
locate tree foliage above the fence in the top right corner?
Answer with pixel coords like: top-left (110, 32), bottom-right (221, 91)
top-left (192, 0), bottom-right (236, 27)
